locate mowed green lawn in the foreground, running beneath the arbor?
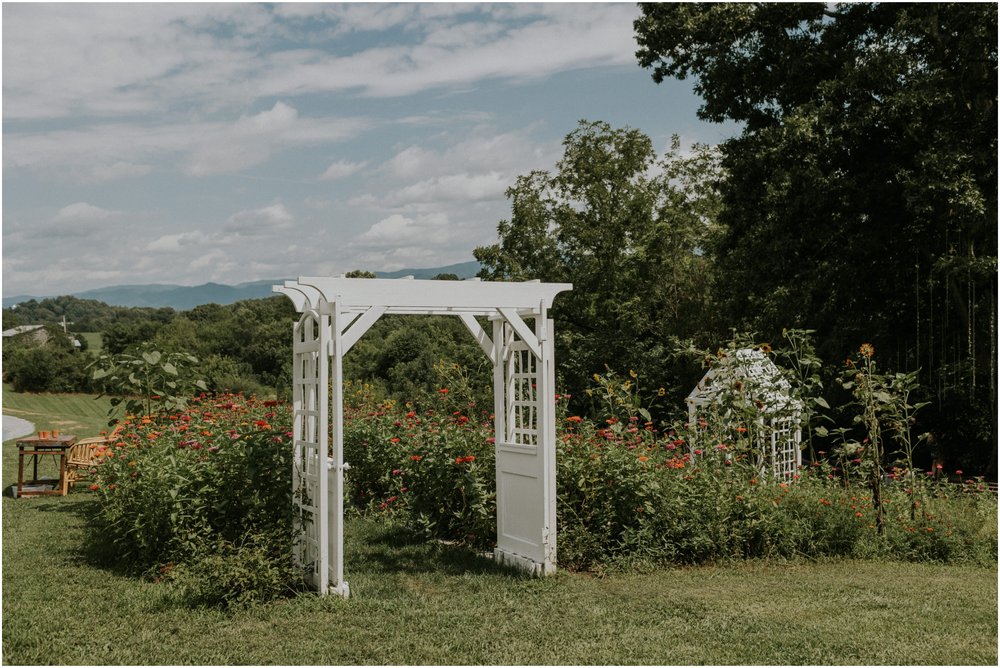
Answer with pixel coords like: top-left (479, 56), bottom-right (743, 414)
top-left (3, 392), bottom-right (997, 665)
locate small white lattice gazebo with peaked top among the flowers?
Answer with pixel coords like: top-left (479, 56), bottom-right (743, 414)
top-left (686, 348), bottom-right (802, 479)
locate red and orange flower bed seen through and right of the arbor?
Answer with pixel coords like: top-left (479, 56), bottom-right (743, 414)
top-left (345, 374), bottom-right (996, 569)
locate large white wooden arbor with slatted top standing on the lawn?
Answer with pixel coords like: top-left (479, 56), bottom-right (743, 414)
top-left (273, 277), bottom-right (573, 597)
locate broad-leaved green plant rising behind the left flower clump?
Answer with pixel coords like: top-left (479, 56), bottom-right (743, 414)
top-left (91, 343), bottom-right (208, 417)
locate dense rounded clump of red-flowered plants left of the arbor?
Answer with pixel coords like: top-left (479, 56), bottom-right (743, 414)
top-left (92, 395), bottom-right (301, 606)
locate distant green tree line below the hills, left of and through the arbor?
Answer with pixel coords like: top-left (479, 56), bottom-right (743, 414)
top-left (3, 270), bottom-right (489, 408)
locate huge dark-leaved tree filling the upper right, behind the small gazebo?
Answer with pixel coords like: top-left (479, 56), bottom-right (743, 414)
top-left (635, 3), bottom-right (997, 472)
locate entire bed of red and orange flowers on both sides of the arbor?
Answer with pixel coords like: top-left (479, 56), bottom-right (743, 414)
top-left (91, 344), bottom-right (997, 607)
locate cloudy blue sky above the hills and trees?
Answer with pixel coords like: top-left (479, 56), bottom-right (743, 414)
top-left (3, 3), bottom-right (734, 296)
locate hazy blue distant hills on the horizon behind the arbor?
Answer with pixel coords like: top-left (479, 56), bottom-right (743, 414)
top-left (3, 260), bottom-right (479, 311)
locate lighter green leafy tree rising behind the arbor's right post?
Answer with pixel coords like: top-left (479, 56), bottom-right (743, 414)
top-left (475, 121), bottom-right (718, 412)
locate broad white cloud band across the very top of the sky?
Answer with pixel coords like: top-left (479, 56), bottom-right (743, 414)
top-left (3, 3), bottom-right (638, 120)
